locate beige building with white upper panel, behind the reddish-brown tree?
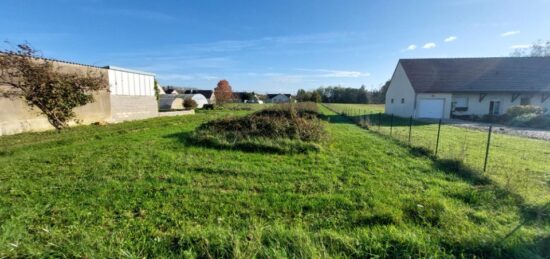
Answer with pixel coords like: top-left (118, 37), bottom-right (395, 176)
top-left (0, 59), bottom-right (158, 135)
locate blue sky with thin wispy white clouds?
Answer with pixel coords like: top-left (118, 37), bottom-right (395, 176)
top-left (0, 0), bottom-right (550, 93)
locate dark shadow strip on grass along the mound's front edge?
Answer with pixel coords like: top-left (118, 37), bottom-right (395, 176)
top-left (165, 132), bottom-right (320, 154)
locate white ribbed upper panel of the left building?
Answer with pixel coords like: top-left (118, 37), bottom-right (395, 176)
top-left (109, 69), bottom-right (155, 96)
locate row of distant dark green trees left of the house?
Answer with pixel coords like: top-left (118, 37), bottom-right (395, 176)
top-left (296, 81), bottom-right (390, 103)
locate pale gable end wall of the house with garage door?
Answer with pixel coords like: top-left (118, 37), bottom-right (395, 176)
top-left (385, 63), bottom-right (415, 117)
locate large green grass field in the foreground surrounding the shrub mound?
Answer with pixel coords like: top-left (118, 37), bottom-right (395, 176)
top-left (0, 105), bottom-right (550, 258)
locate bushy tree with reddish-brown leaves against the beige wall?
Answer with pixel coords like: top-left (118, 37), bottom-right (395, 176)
top-left (0, 44), bottom-right (107, 130)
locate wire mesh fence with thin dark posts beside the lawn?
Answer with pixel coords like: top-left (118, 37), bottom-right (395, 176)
top-left (325, 104), bottom-right (550, 203)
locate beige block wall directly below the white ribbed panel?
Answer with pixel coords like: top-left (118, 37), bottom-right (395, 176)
top-left (109, 95), bottom-right (158, 122)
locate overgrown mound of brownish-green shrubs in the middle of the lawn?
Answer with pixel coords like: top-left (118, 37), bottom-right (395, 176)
top-left (192, 103), bottom-right (324, 153)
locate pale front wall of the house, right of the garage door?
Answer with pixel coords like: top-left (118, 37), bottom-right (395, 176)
top-left (453, 93), bottom-right (550, 116)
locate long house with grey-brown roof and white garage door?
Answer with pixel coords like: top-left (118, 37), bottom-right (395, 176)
top-left (385, 57), bottom-right (550, 119)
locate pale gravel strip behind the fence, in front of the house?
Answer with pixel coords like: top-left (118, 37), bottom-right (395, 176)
top-left (445, 119), bottom-right (550, 140)
